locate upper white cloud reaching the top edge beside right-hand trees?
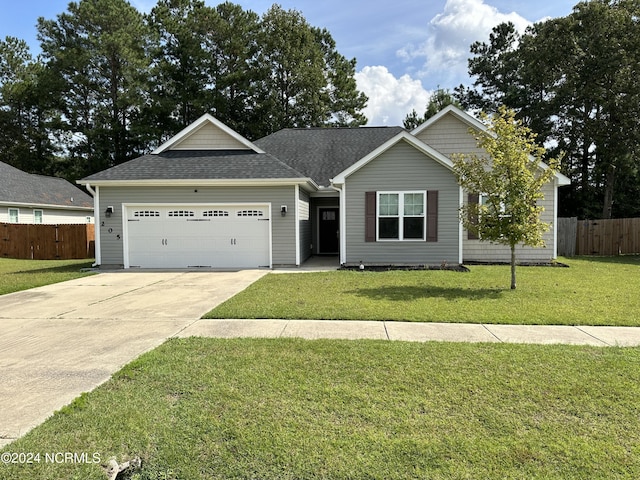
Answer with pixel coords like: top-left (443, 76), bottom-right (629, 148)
top-left (396, 0), bottom-right (531, 88)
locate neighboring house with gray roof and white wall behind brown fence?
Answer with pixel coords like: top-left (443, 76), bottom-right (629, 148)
top-left (0, 162), bottom-right (94, 225)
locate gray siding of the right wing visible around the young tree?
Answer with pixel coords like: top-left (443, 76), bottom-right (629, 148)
top-left (463, 183), bottom-right (555, 262)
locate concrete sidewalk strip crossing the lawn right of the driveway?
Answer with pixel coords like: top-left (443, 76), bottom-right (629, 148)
top-left (177, 320), bottom-right (640, 347)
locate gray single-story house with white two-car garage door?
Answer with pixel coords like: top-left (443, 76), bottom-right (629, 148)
top-left (80, 107), bottom-right (569, 268)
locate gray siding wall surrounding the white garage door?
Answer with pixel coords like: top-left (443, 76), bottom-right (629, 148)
top-left (96, 186), bottom-right (297, 266)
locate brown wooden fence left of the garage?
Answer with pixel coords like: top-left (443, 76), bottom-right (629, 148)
top-left (0, 223), bottom-right (95, 260)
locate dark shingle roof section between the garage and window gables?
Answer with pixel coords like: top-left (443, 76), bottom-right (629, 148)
top-left (253, 127), bottom-right (405, 186)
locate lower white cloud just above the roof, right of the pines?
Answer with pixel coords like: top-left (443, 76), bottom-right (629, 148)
top-left (355, 66), bottom-right (431, 126)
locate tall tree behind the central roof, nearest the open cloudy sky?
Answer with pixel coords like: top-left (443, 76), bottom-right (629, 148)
top-left (258, 5), bottom-right (367, 135)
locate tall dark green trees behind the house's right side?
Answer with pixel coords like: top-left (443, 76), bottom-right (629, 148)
top-left (456, 0), bottom-right (640, 218)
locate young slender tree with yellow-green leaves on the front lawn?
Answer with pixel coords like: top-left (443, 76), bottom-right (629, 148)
top-left (454, 106), bottom-right (558, 289)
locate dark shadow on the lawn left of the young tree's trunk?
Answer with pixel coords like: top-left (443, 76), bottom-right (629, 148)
top-left (346, 286), bottom-right (503, 302)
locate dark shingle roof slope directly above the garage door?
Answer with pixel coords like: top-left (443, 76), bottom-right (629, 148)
top-left (83, 150), bottom-right (304, 183)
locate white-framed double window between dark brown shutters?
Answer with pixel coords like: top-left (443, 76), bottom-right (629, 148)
top-left (377, 191), bottom-right (426, 241)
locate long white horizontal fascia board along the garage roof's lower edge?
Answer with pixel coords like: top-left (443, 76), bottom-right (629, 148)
top-left (76, 178), bottom-right (319, 189)
